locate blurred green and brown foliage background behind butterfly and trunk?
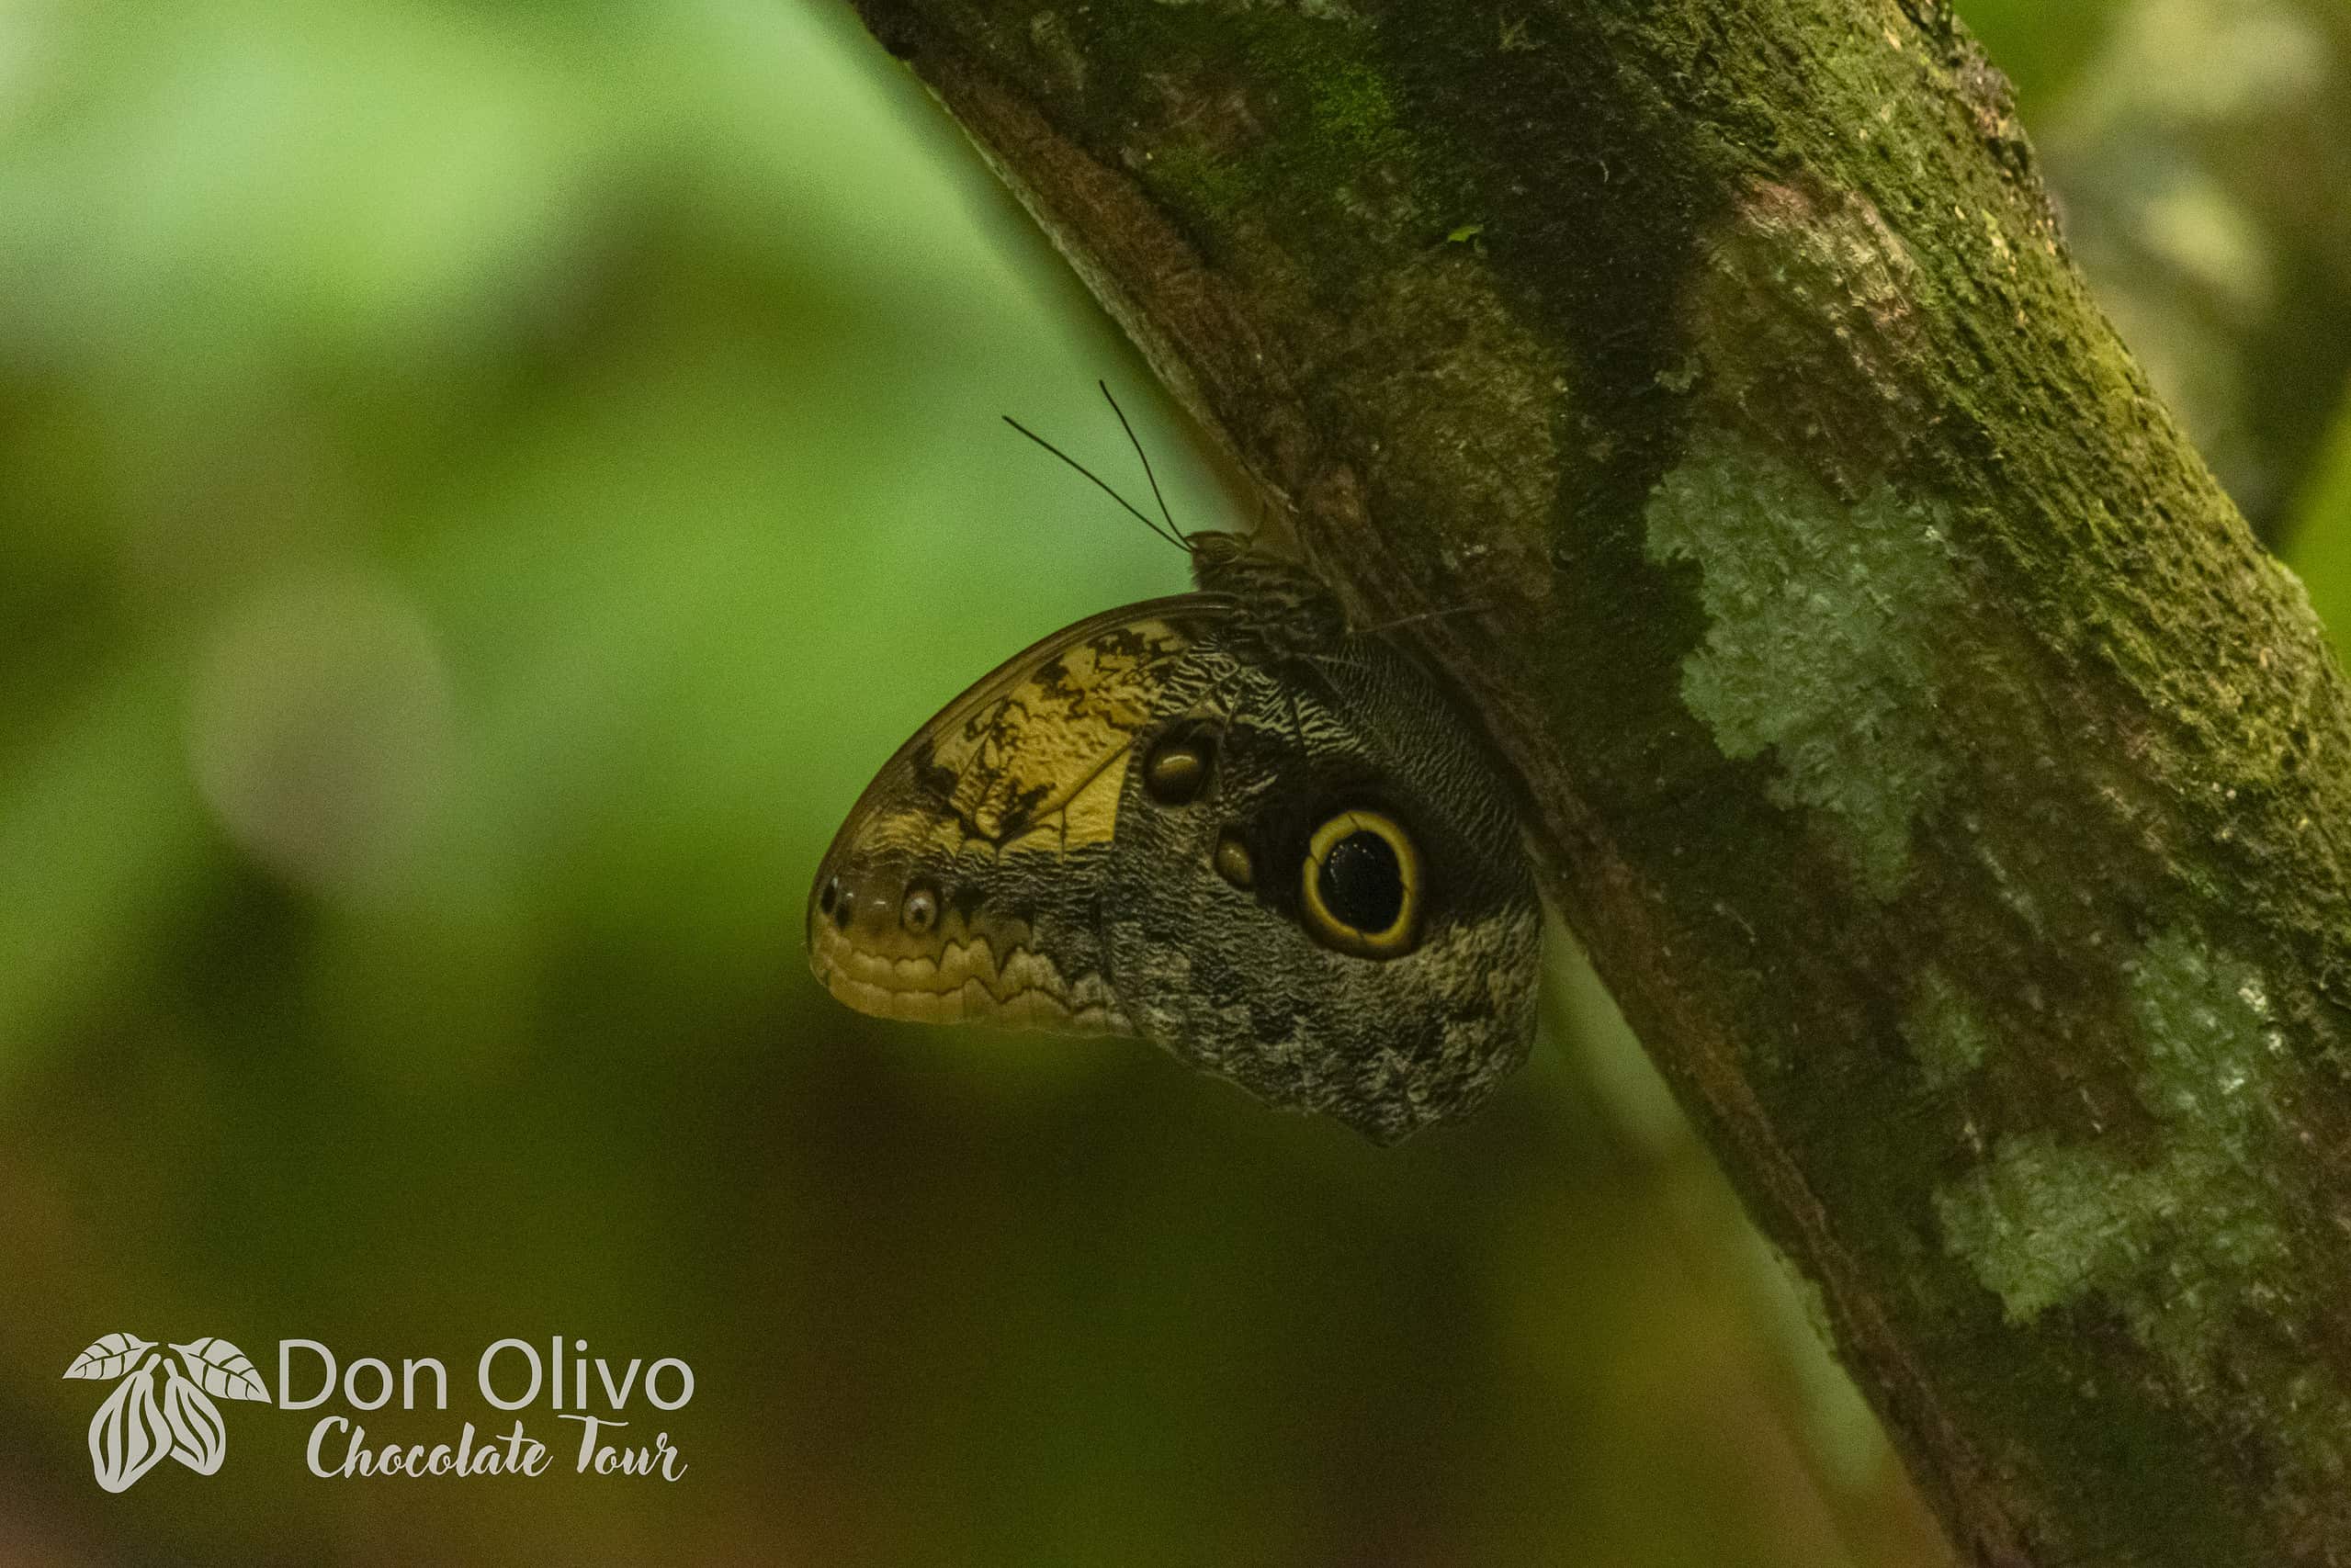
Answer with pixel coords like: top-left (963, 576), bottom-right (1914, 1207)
top-left (0, 0), bottom-right (2351, 1568)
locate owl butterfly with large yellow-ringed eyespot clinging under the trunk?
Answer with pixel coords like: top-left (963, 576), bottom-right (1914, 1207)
top-left (808, 495), bottom-right (1540, 1143)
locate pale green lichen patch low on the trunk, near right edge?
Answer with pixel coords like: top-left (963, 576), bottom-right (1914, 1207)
top-left (1935, 931), bottom-right (2288, 1389)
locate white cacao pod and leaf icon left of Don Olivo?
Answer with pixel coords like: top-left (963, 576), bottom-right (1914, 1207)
top-left (66, 1333), bottom-right (270, 1493)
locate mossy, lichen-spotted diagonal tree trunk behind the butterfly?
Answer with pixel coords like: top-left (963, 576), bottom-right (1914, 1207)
top-left (842, 0), bottom-right (2351, 1565)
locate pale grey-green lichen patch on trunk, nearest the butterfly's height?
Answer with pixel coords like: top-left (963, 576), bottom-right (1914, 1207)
top-left (1645, 434), bottom-right (1963, 898)
